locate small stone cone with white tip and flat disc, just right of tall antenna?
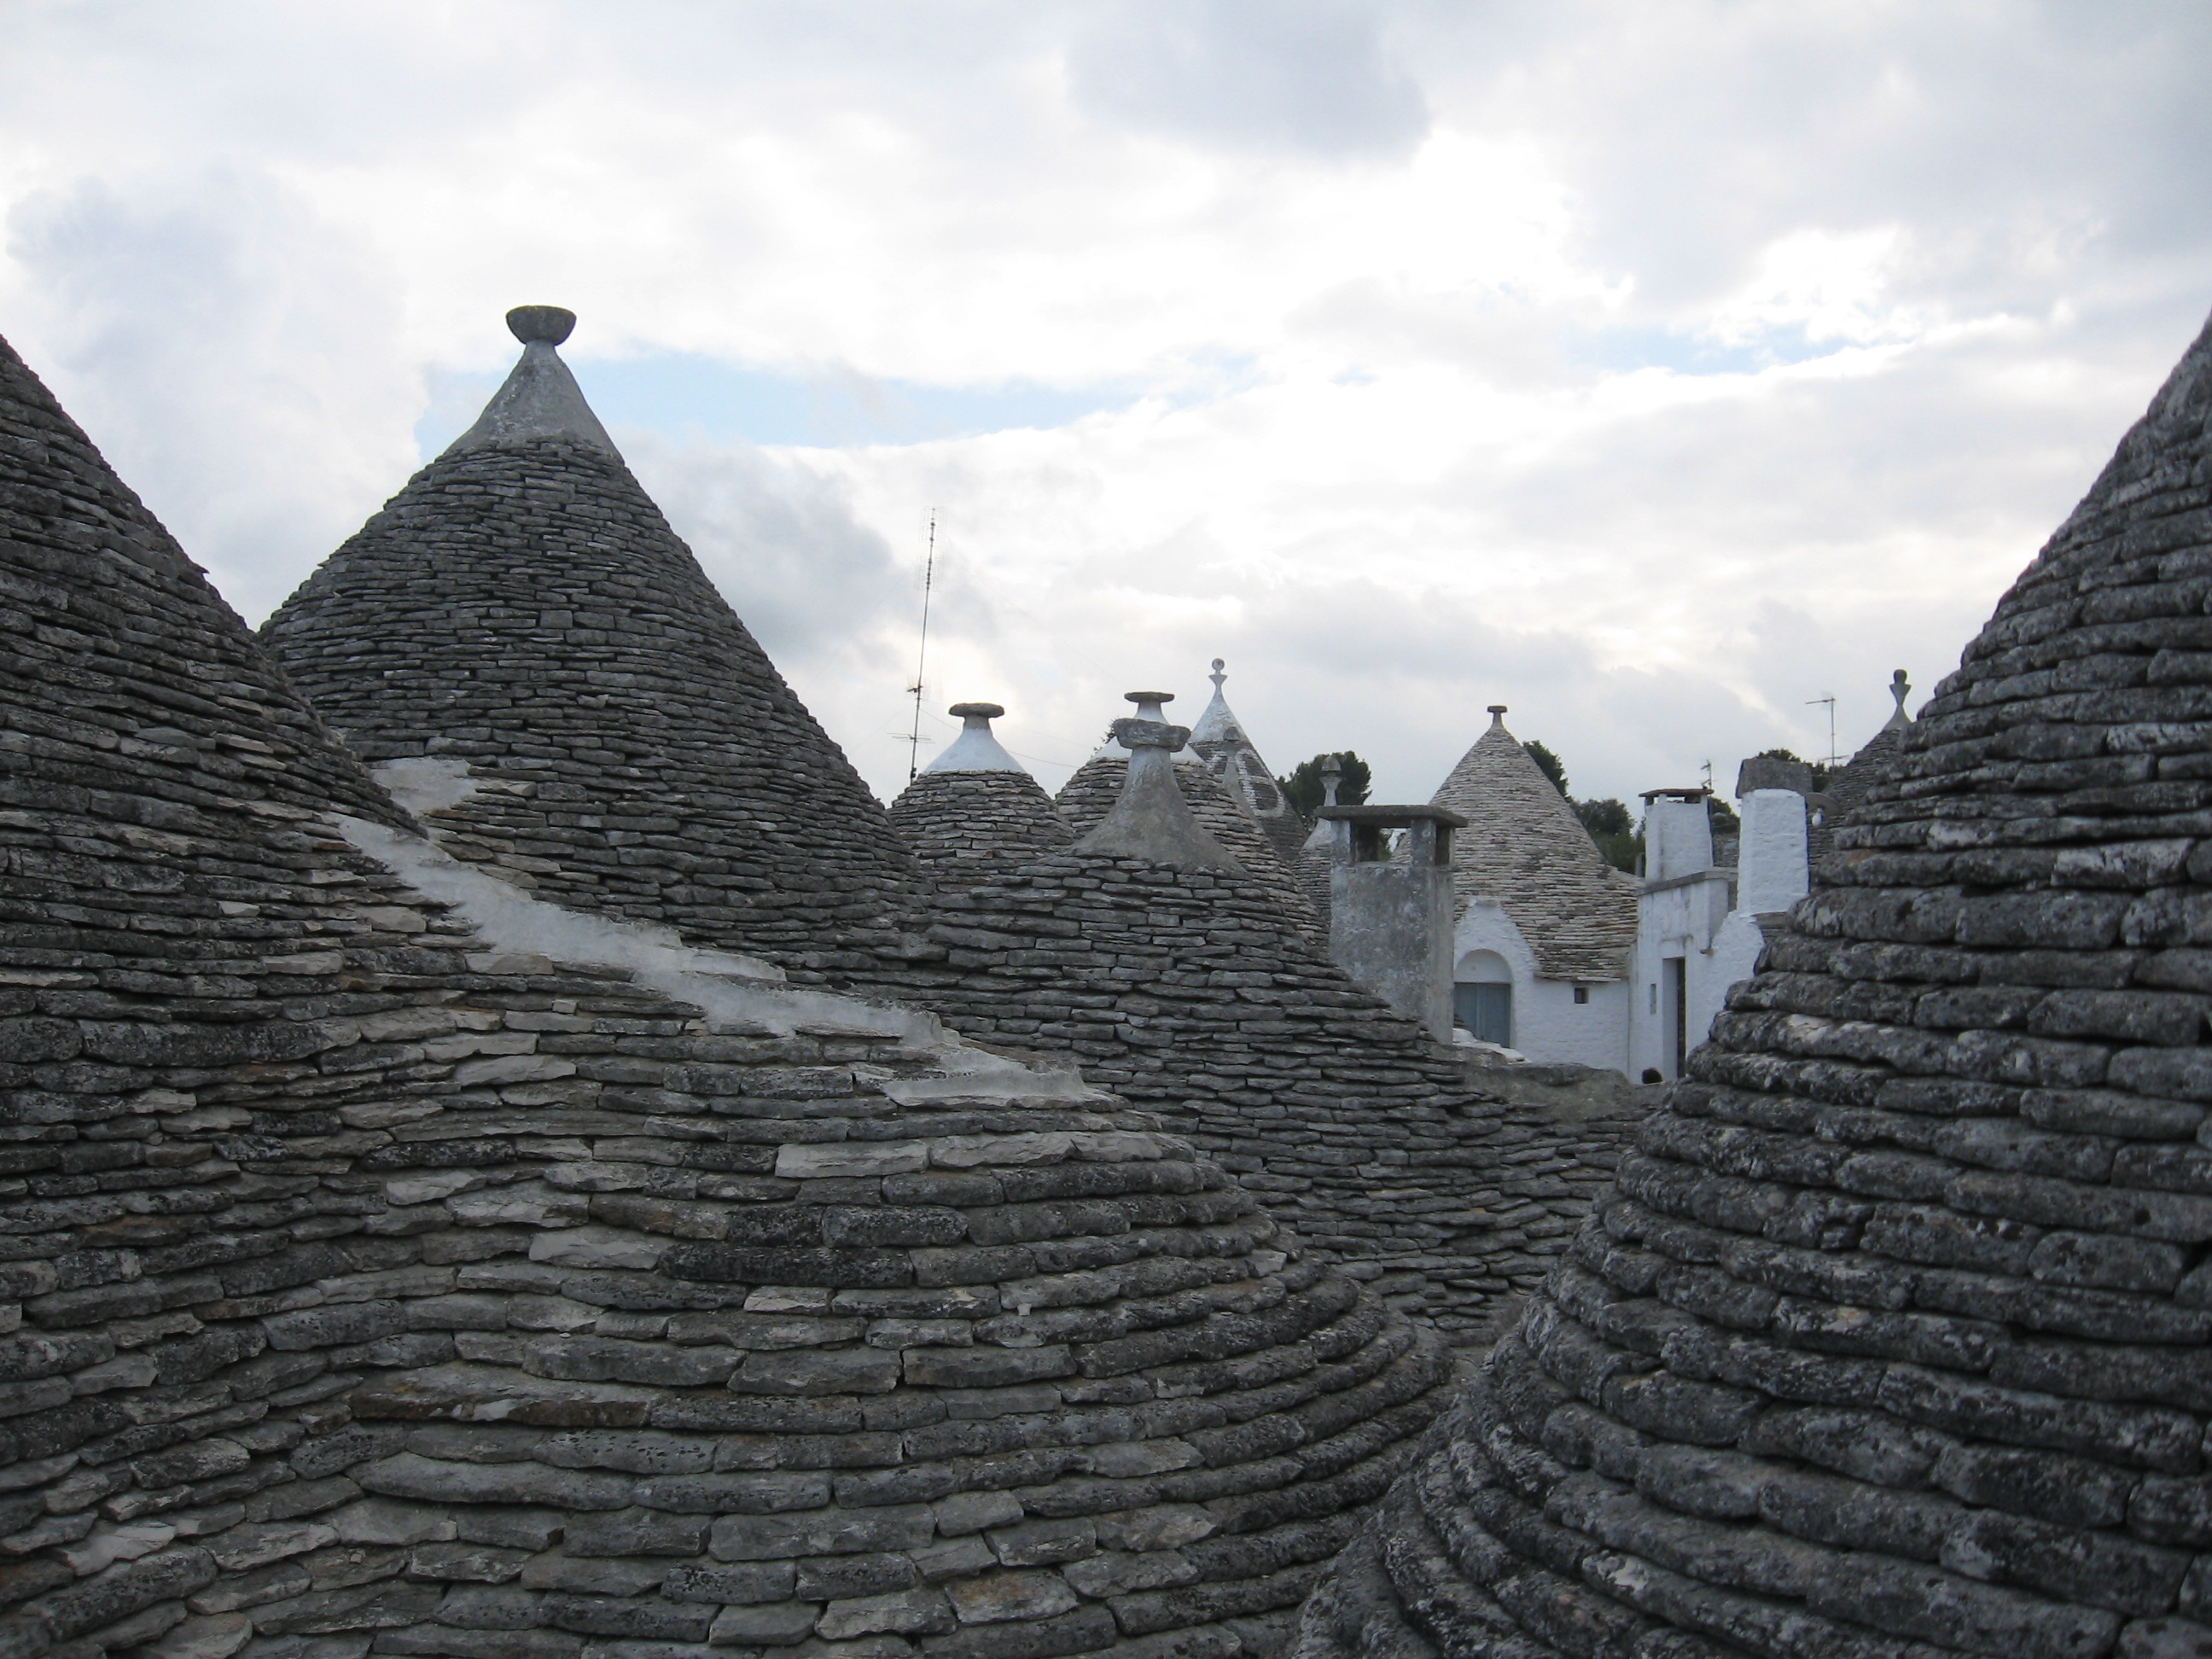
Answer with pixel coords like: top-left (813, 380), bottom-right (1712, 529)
top-left (892, 703), bottom-right (1075, 892)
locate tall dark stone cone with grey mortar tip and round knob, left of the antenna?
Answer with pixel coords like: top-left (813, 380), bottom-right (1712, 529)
top-left (263, 307), bottom-right (911, 973)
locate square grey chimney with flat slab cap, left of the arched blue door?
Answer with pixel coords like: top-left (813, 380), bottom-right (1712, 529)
top-left (1318, 805), bottom-right (1466, 1042)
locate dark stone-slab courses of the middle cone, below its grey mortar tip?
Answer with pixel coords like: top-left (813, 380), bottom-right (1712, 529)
top-left (911, 858), bottom-right (1633, 1342)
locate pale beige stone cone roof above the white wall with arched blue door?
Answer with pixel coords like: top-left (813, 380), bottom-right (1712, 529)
top-left (1429, 707), bottom-right (1637, 980)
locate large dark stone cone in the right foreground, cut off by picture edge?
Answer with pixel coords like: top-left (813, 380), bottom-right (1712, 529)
top-left (1301, 305), bottom-right (2212, 1659)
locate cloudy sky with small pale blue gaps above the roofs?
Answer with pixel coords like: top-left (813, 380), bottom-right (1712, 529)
top-left (0, 0), bottom-right (2212, 799)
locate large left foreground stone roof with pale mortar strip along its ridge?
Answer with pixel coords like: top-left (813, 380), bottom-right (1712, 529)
top-left (0, 325), bottom-right (1469, 1659)
